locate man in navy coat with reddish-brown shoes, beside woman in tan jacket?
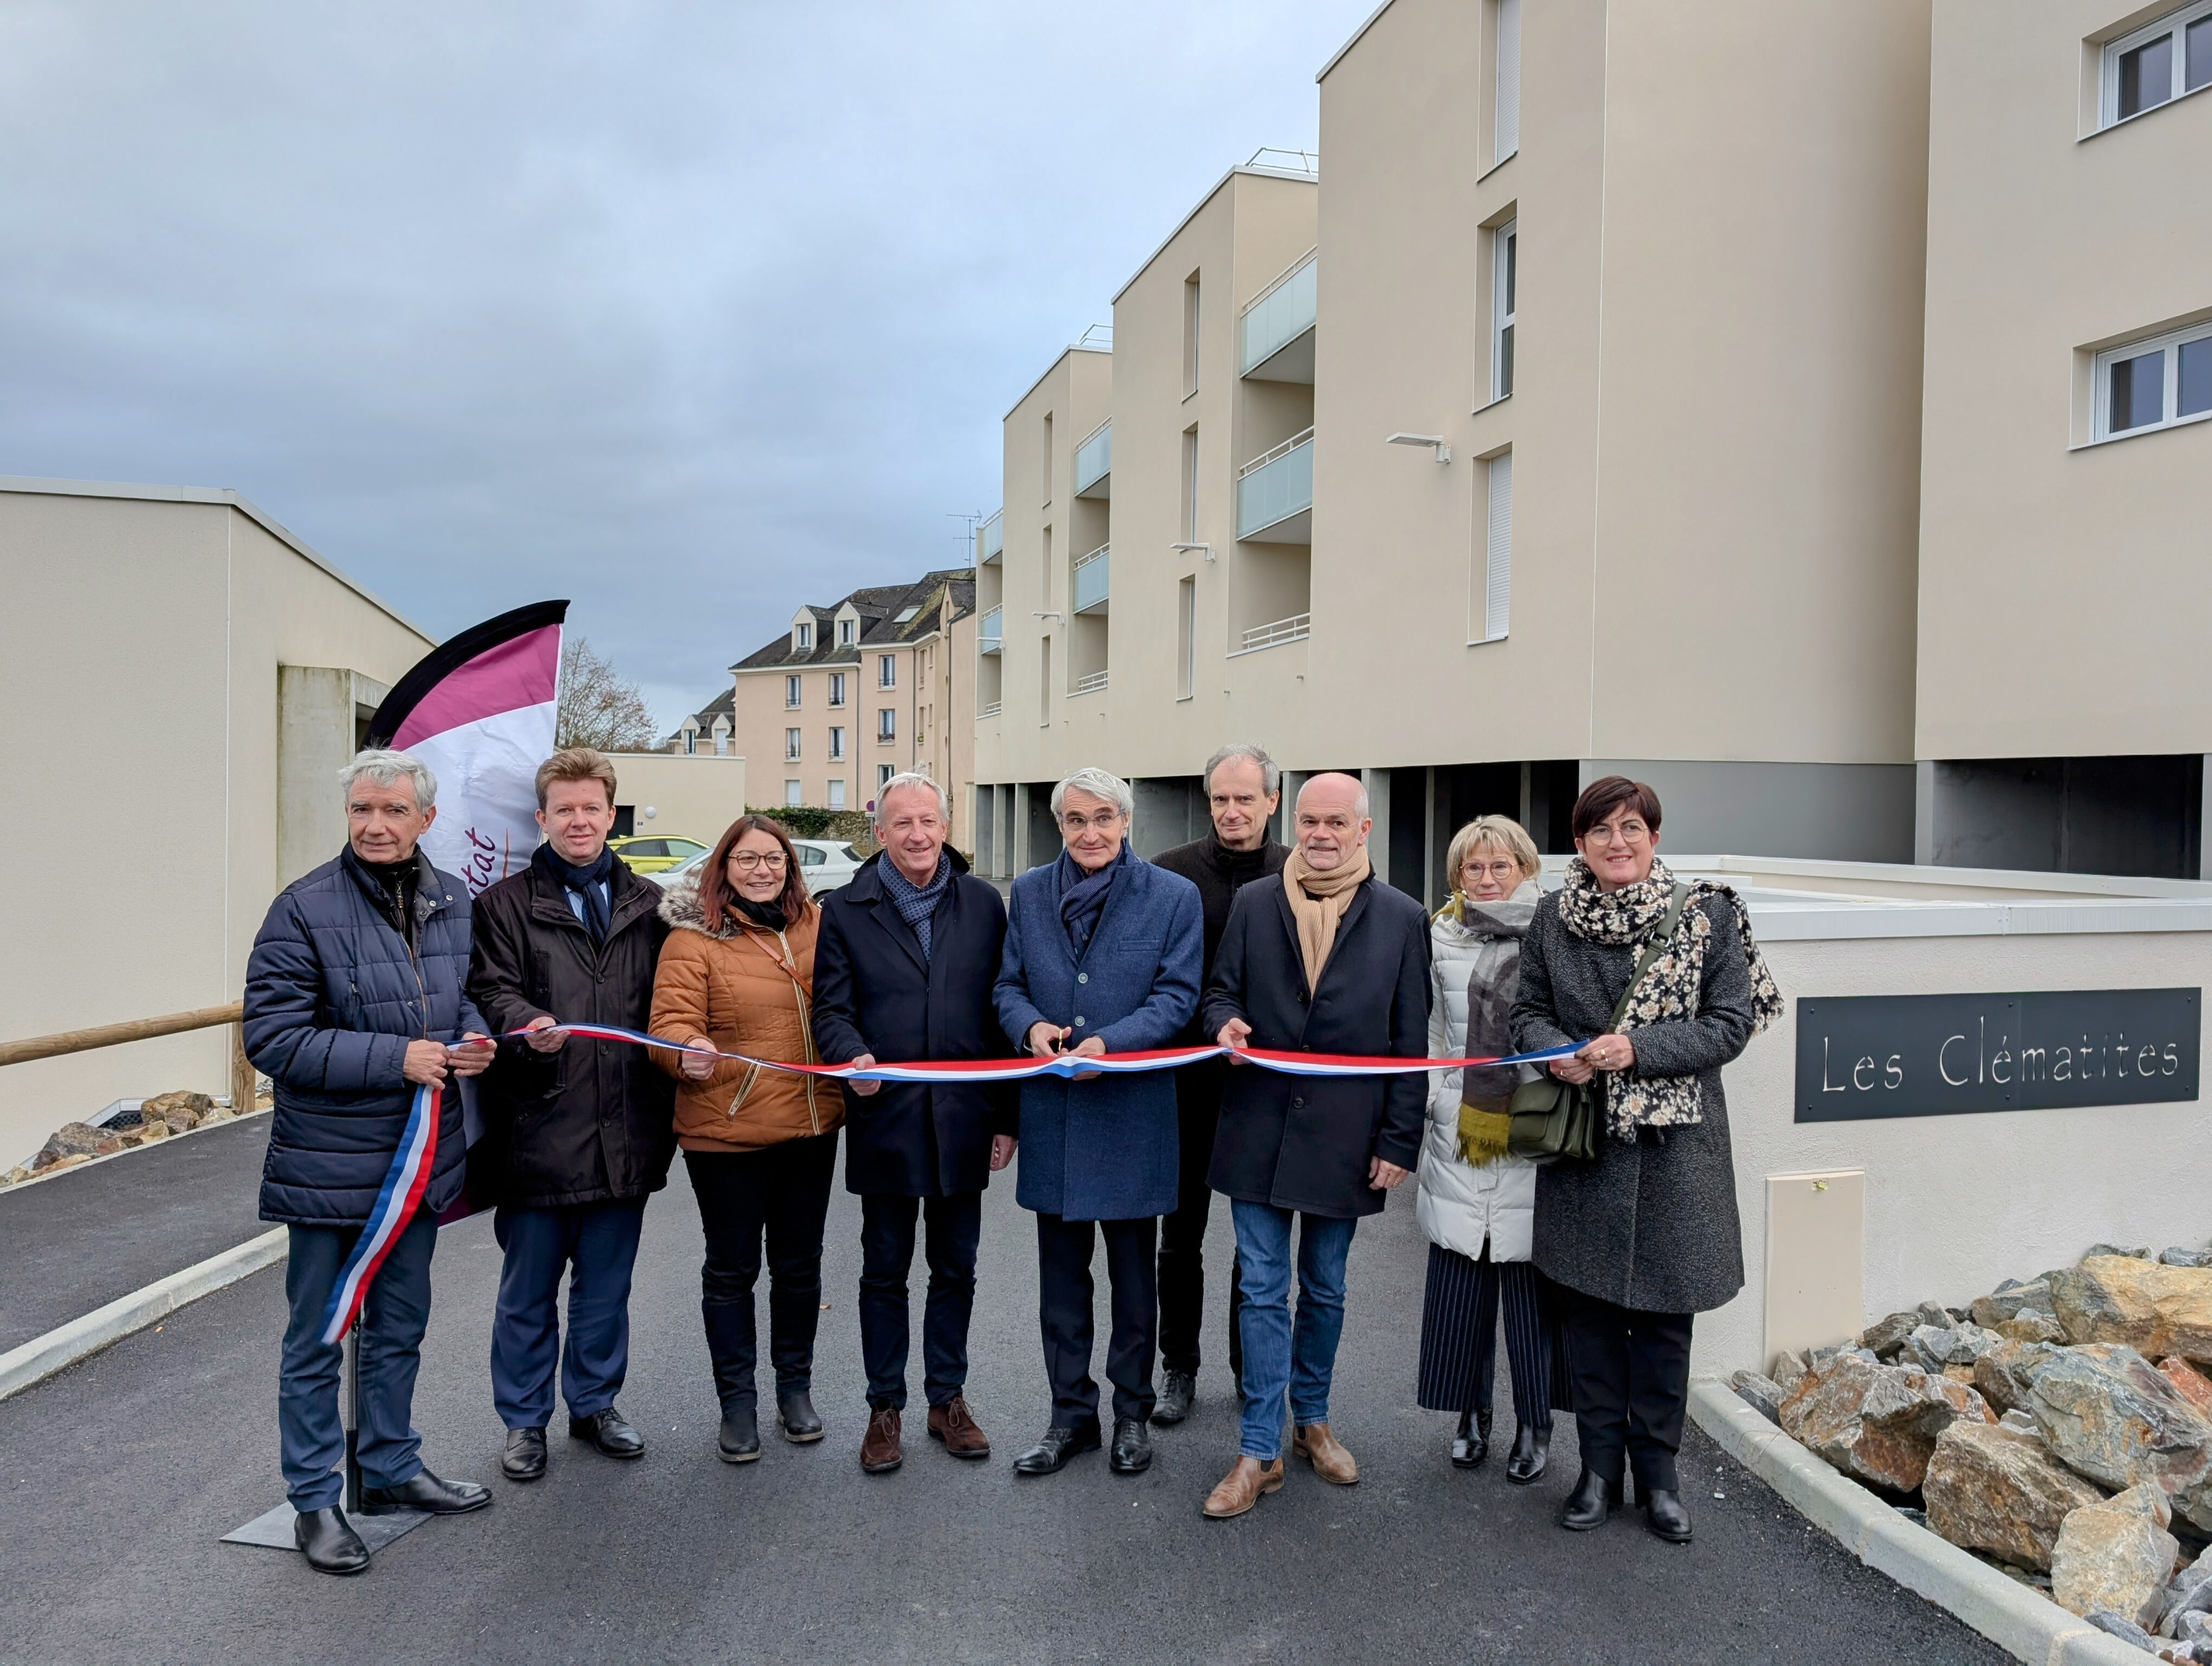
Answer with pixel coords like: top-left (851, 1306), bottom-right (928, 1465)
top-left (814, 774), bottom-right (1015, 1476)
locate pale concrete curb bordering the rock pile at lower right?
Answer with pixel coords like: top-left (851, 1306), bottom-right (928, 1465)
top-left (1690, 1376), bottom-right (2155, 1666)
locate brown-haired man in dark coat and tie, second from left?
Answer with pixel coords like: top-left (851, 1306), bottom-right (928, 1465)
top-left (469, 746), bottom-right (677, 1480)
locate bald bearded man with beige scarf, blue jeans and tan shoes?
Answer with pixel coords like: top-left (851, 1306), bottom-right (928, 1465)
top-left (1206, 774), bottom-right (1429, 1518)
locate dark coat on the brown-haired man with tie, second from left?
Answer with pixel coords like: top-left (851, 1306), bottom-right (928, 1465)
top-left (469, 863), bottom-right (677, 1208)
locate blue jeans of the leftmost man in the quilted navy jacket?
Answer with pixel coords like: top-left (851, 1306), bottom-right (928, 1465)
top-left (276, 1208), bottom-right (438, 1511)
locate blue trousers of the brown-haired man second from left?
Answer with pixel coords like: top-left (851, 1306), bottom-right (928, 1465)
top-left (491, 1197), bottom-right (646, 1429)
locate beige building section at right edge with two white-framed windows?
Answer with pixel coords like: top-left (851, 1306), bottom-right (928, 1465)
top-left (1913, 0), bottom-right (2212, 879)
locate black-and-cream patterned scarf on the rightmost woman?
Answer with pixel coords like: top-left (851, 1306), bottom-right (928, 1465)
top-left (1559, 856), bottom-right (1783, 1139)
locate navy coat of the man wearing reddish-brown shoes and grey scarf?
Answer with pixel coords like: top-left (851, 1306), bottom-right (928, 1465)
top-left (814, 845), bottom-right (1020, 1197)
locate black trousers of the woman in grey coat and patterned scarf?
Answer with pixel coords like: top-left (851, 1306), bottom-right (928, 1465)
top-left (1553, 1285), bottom-right (1696, 1491)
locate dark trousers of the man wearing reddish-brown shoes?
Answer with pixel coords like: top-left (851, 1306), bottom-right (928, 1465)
top-left (860, 1193), bottom-right (982, 1412)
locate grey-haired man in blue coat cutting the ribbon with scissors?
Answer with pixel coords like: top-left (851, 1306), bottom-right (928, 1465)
top-left (998, 770), bottom-right (1206, 1476)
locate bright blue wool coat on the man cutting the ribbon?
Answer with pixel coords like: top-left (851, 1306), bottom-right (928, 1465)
top-left (995, 854), bottom-right (1206, 1221)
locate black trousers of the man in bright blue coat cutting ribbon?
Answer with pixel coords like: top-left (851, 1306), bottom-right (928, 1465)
top-left (1038, 1215), bottom-right (1159, 1429)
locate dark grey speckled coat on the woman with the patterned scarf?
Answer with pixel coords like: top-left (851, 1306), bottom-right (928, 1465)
top-left (1513, 892), bottom-right (1752, 1314)
